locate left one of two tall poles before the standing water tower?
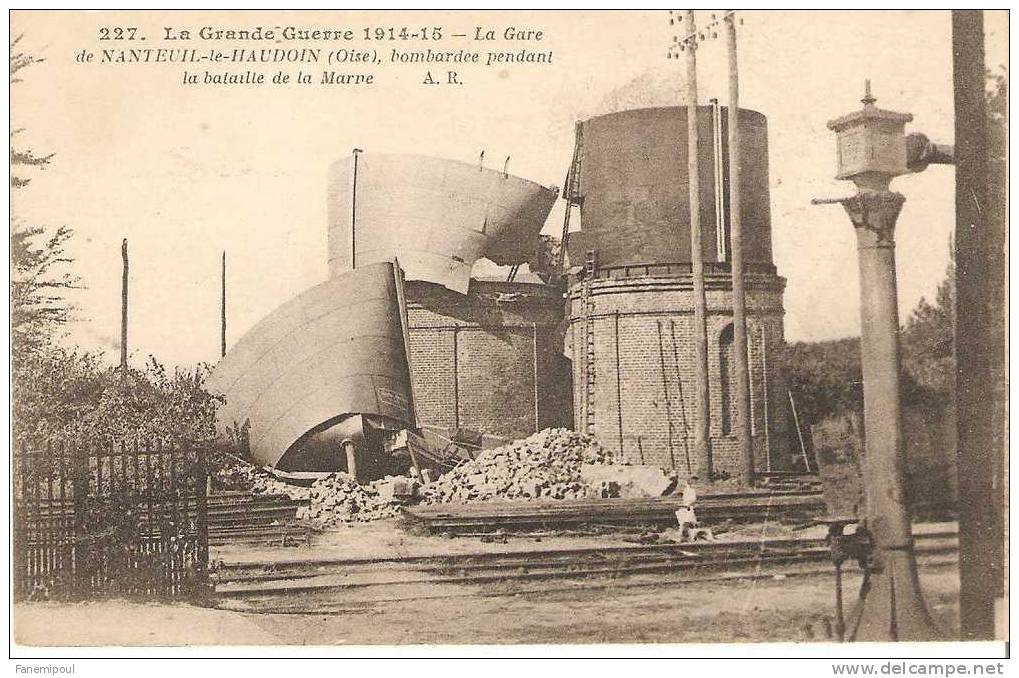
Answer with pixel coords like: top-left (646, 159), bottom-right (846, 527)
top-left (685, 9), bottom-right (712, 480)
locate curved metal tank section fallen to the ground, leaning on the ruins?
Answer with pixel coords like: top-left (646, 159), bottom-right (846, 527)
top-left (208, 262), bottom-right (415, 466)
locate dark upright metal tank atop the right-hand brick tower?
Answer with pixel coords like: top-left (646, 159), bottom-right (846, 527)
top-left (574, 106), bottom-right (773, 270)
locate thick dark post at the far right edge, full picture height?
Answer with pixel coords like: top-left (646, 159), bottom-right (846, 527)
top-left (952, 10), bottom-right (1008, 640)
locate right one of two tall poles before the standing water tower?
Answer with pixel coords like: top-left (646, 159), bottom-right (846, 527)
top-left (725, 11), bottom-right (767, 487)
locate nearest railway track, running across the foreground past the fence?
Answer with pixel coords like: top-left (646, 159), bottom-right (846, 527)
top-left (214, 530), bottom-right (958, 614)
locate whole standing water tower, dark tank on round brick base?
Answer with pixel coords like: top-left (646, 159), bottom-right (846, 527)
top-left (564, 105), bottom-right (793, 477)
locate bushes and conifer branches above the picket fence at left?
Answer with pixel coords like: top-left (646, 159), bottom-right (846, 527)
top-left (10, 37), bottom-right (219, 448)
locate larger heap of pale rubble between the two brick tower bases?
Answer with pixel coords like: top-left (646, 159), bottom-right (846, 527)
top-left (422, 428), bottom-right (615, 504)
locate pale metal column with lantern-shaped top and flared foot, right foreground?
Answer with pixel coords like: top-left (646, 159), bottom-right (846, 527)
top-left (814, 81), bottom-right (941, 641)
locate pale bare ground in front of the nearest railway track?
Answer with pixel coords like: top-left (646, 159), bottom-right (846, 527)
top-left (14, 568), bottom-right (959, 645)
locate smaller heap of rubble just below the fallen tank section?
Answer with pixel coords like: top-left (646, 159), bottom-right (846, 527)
top-left (298, 471), bottom-right (417, 527)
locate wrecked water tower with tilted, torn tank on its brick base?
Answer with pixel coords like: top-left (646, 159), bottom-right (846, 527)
top-left (328, 151), bottom-right (572, 438)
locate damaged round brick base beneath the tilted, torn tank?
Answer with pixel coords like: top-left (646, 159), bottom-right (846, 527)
top-left (407, 279), bottom-right (573, 438)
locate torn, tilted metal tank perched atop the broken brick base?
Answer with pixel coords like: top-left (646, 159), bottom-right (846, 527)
top-left (328, 153), bottom-right (556, 294)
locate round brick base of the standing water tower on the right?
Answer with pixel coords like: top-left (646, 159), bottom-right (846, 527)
top-left (565, 275), bottom-right (792, 476)
